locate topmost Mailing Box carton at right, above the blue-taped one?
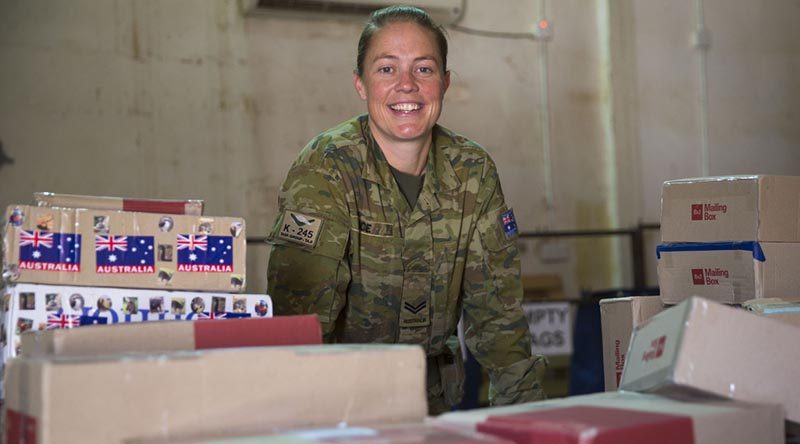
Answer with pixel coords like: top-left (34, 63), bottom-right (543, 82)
top-left (661, 175), bottom-right (800, 242)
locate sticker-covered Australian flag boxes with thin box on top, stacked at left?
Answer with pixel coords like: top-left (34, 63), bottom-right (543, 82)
top-left (0, 193), bottom-right (280, 372)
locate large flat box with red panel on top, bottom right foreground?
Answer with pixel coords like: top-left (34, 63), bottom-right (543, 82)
top-left (434, 392), bottom-right (784, 444)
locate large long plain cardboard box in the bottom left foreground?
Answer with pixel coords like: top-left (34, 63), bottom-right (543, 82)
top-left (4, 345), bottom-right (427, 444)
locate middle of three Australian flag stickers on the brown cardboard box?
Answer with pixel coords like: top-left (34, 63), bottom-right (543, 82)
top-left (94, 235), bottom-right (155, 274)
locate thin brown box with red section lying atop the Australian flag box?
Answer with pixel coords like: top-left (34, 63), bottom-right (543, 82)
top-left (33, 193), bottom-right (203, 216)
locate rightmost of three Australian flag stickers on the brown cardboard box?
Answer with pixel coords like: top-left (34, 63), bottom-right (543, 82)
top-left (177, 234), bottom-right (233, 273)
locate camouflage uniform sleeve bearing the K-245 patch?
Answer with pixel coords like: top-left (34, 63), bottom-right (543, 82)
top-left (267, 150), bottom-right (350, 342)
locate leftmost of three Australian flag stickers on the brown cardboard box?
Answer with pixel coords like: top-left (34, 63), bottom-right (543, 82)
top-left (19, 230), bottom-right (81, 272)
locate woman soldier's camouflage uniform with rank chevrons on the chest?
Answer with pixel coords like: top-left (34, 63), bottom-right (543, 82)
top-left (267, 115), bottom-right (544, 413)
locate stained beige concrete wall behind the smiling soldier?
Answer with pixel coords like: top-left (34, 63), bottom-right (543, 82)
top-left (0, 0), bottom-right (800, 295)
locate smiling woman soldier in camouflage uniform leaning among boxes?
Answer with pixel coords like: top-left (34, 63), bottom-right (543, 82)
top-left (267, 6), bottom-right (544, 414)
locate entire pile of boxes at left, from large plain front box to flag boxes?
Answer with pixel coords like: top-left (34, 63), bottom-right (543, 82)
top-left (2, 195), bottom-right (434, 443)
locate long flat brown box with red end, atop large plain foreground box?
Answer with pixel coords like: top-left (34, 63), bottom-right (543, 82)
top-left (21, 315), bottom-right (322, 356)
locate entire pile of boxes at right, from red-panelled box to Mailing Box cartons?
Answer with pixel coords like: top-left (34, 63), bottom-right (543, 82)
top-left (450, 176), bottom-right (800, 444)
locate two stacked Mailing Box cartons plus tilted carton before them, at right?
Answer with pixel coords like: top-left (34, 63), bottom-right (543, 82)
top-left (608, 175), bottom-right (800, 438)
